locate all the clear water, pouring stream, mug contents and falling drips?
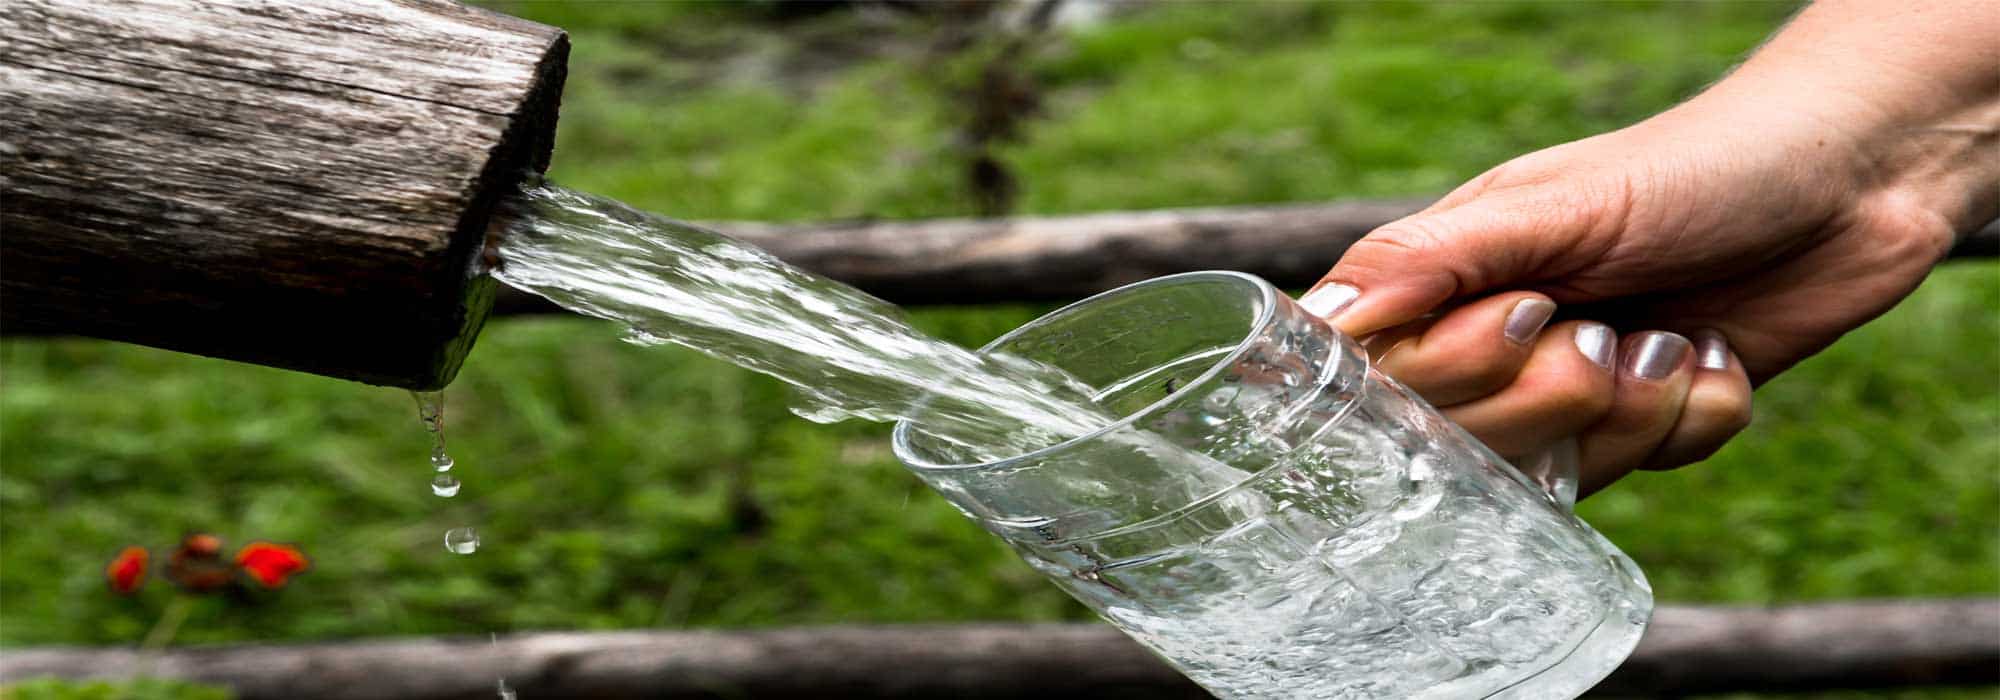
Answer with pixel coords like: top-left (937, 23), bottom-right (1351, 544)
top-left (418, 184), bottom-right (1650, 698)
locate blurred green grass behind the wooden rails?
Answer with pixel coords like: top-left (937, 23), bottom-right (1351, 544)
top-left (0, 2), bottom-right (2000, 698)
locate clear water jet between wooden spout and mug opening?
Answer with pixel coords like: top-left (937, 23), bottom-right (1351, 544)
top-left (492, 184), bottom-right (1110, 460)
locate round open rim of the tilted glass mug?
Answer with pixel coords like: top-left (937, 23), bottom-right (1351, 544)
top-left (890, 270), bottom-right (1282, 472)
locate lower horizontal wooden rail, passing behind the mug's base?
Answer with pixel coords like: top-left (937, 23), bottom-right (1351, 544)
top-left (0, 600), bottom-right (2000, 700)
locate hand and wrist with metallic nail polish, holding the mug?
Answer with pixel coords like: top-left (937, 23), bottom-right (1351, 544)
top-left (1302, 4), bottom-right (2000, 494)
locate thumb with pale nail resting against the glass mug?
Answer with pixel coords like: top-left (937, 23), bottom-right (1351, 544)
top-left (1300, 188), bottom-right (1592, 338)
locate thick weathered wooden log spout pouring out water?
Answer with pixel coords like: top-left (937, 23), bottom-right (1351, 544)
top-left (0, 0), bottom-right (568, 388)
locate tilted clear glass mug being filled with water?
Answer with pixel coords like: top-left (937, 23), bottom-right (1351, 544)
top-left (894, 272), bottom-right (1652, 700)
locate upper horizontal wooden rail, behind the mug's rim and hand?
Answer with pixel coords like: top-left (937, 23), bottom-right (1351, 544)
top-left (494, 198), bottom-right (2000, 314)
